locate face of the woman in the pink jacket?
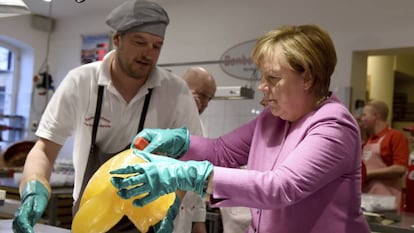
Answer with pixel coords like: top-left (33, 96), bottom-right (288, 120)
top-left (259, 50), bottom-right (309, 122)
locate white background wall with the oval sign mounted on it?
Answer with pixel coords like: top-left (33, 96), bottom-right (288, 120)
top-left (0, 0), bottom-right (414, 157)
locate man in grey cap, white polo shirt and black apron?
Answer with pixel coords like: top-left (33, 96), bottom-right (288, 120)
top-left (13, 0), bottom-right (202, 232)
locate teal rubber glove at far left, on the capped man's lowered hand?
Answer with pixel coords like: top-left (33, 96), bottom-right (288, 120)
top-left (13, 180), bottom-right (49, 233)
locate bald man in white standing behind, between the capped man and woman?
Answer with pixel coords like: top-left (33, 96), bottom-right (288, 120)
top-left (174, 67), bottom-right (216, 233)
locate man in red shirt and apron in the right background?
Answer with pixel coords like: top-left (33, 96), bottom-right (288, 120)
top-left (361, 101), bottom-right (409, 209)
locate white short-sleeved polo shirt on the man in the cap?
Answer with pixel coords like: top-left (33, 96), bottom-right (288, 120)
top-left (36, 51), bottom-right (202, 200)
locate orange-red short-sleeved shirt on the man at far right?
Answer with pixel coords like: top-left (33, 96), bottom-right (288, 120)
top-left (364, 126), bottom-right (410, 167)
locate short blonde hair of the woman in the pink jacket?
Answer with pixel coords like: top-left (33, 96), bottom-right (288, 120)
top-left (252, 25), bottom-right (337, 96)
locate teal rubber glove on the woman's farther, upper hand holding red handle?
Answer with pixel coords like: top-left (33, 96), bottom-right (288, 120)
top-left (131, 127), bottom-right (190, 158)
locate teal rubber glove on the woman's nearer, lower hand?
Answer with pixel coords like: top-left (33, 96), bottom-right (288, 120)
top-left (110, 150), bottom-right (214, 207)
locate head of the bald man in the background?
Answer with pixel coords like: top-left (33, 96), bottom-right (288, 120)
top-left (183, 67), bottom-right (216, 114)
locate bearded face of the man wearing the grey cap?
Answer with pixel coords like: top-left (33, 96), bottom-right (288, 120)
top-left (114, 32), bottom-right (164, 79)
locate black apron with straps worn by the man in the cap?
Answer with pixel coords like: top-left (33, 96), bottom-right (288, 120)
top-left (72, 86), bottom-right (154, 233)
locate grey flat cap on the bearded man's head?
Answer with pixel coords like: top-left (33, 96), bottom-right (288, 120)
top-left (106, 0), bottom-right (170, 38)
